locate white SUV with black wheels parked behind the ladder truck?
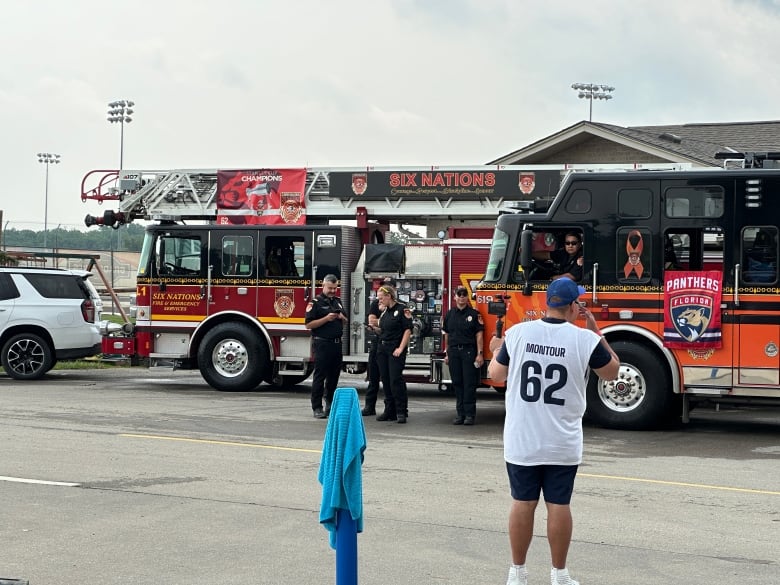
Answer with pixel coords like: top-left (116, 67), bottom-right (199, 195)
top-left (0, 267), bottom-right (101, 380)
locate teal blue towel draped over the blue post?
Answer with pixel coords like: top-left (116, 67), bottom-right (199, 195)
top-left (317, 388), bottom-right (366, 549)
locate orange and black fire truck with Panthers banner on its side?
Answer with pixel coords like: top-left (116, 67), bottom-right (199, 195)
top-left (476, 153), bottom-right (780, 429)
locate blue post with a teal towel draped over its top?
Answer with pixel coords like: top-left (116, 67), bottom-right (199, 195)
top-left (317, 388), bottom-right (366, 585)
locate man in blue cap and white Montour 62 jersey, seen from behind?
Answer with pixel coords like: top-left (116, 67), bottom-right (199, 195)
top-left (488, 278), bottom-right (620, 585)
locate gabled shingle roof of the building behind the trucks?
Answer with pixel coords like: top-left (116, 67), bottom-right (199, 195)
top-left (488, 120), bottom-right (780, 166)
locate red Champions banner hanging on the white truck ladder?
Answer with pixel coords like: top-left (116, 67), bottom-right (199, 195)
top-left (217, 169), bottom-right (306, 225)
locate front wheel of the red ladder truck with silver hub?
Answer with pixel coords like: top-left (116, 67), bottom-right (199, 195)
top-left (198, 323), bottom-right (269, 392)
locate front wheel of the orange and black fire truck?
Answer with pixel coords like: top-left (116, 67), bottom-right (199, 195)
top-left (587, 341), bottom-right (675, 430)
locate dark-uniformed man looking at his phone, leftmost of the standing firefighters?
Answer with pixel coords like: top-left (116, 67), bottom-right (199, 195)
top-left (306, 274), bottom-right (347, 418)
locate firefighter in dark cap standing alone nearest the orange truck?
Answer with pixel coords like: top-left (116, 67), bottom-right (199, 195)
top-left (442, 286), bottom-right (485, 425)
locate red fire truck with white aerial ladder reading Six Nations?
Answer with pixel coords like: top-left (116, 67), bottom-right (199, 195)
top-left (81, 165), bottom-right (684, 391)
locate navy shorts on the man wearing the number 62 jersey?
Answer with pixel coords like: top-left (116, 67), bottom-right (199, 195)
top-left (506, 463), bottom-right (579, 506)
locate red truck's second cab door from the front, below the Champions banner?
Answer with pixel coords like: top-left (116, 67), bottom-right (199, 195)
top-left (208, 229), bottom-right (264, 316)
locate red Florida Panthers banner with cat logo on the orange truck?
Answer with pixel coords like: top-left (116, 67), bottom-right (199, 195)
top-left (664, 270), bottom-right (723, 349)
